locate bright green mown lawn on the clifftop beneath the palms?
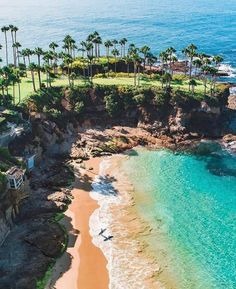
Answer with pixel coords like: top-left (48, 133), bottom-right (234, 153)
top-left (9, 72), bottom-right (209, 103)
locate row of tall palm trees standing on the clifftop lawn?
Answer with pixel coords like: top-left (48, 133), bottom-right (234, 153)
top-left (0, 25), bottom-right (223, 106)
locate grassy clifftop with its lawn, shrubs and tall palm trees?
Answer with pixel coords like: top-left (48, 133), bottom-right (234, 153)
top-left (0, 25), bottom-right (223, 106)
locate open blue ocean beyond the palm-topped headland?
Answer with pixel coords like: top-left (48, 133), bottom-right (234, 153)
top-left (0, 0), bottom-right (236, 80)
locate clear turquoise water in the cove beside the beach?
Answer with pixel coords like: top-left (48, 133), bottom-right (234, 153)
top-left (124, 144), bottom-right (236, 289)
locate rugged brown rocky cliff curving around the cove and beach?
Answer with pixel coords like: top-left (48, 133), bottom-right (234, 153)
top-left (0, 86), bottom-right (235, 289)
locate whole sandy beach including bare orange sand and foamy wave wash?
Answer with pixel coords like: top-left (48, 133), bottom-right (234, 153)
top-left (47, 155), bottom-right (165, 289)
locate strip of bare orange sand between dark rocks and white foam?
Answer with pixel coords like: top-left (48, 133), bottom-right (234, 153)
top-left (46, 158), bottom-right (109, 289)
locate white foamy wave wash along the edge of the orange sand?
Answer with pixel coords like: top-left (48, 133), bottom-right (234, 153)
top-left (89, 159), bottom-right (164, 289)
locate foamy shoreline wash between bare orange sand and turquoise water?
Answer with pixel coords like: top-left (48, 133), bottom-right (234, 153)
top-left (90, 155), bottom-right (168, 289)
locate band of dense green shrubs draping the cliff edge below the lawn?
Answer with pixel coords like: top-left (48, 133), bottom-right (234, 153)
top-left (28, 85), bottom-right (228, 123)
